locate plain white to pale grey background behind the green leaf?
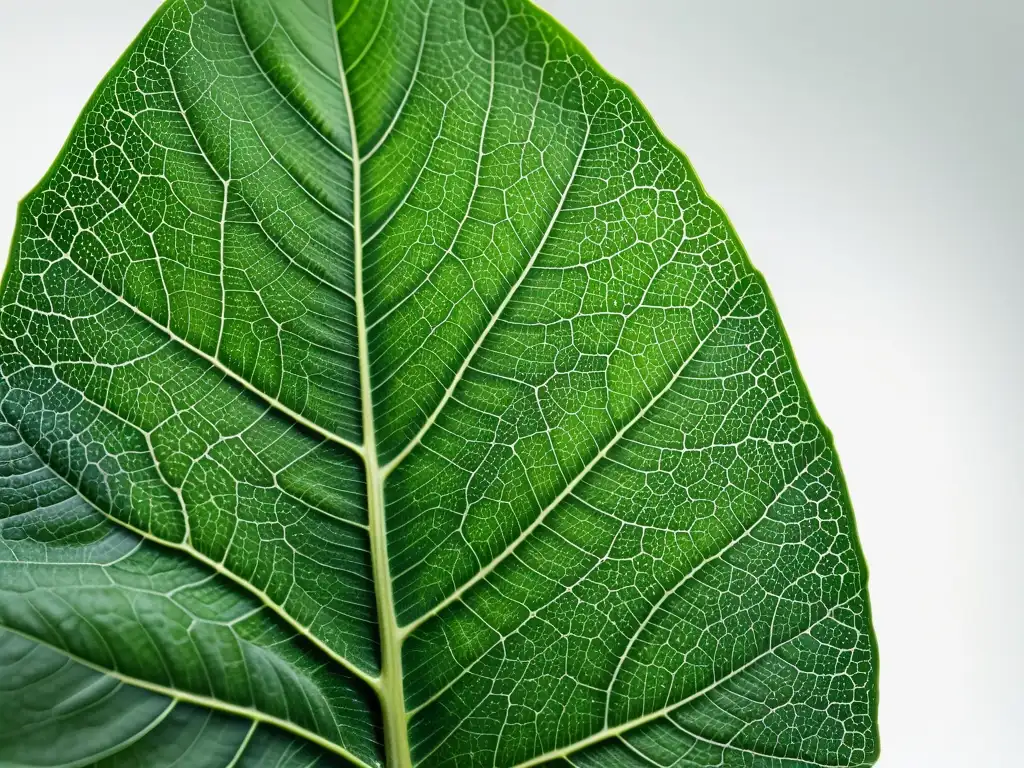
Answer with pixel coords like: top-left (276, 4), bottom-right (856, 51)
top-left (0, 0), bottom-right (1024, 768)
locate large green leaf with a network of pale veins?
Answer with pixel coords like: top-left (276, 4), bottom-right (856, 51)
top-left (0, 0), bottom-right (878, 768)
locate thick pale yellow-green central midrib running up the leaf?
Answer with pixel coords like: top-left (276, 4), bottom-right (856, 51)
top-left (328, 0), bottom-right (413, 768)
